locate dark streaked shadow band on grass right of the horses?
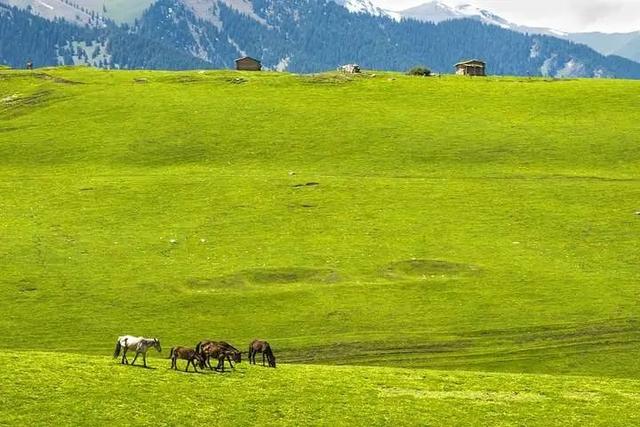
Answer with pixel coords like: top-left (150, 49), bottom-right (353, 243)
top-left (279, 316), bottom-right (640, 370)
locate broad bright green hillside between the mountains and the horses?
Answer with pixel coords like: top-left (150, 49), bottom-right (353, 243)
top-left (0, 69), bottom-right (640, 378)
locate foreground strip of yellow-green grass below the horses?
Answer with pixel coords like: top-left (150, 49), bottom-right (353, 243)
top-left (0, 352), bottom-right (640, 426)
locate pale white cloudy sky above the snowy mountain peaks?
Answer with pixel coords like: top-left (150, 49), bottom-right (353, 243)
top-left (373, 0), bottom-right (640, 32)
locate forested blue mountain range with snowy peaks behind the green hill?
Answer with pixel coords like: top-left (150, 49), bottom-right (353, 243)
top-left (0, 0), bottom-right (640, 78)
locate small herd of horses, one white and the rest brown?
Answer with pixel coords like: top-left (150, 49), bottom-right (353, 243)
top-left (113, 335), bottom-right (276, 372)
